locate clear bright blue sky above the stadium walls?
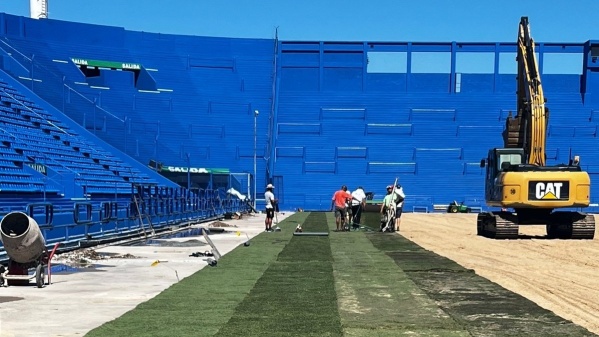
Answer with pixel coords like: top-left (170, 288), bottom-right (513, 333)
top-left (0, 0), bottom-right (599, 72)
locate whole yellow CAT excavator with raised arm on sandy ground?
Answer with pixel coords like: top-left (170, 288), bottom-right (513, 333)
top-left (477, 17), bottom-right (595, 239)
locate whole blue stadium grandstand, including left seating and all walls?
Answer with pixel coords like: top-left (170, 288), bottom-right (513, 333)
top-left (0, 5), bottom-right (599, 248)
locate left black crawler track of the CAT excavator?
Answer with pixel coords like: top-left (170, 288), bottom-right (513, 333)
top-left (477, 212), bottom-right (519, 239)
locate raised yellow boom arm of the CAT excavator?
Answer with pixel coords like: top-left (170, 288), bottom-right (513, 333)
top-left (503, 17), bottom-right (549, 167)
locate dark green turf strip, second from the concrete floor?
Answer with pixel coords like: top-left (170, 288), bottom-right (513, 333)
top-left (216, 213), bottom-right (342, 337)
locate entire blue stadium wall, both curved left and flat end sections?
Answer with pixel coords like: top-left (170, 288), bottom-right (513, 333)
top-left (0, 15), bottom-right (599, 211)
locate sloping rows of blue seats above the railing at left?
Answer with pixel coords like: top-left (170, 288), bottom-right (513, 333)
top-left (0, 74), bottom-right (174, 197)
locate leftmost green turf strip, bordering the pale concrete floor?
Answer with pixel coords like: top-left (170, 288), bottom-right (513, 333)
top-left (86, 213), bottom-right (309, 337)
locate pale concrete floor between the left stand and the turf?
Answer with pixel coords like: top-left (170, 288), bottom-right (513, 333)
top-left (0, 213), bottom-right (292, 337)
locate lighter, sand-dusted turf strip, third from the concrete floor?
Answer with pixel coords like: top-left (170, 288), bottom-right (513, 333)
top-left (328, 214), bottom-right (469, 336)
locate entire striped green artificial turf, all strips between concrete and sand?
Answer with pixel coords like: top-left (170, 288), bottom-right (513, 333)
top-left (87, 212), bottom-right (594, 337)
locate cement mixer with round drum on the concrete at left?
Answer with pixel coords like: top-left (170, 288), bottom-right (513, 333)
top-left (0, 212), bottom-right (59, 288)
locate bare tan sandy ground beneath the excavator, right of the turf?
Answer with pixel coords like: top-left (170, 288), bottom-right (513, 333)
top-left (400, 213), bottom-right (599, 334)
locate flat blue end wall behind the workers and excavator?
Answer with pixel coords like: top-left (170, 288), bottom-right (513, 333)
top-left (272, 41), bottom-right (599, 211)
